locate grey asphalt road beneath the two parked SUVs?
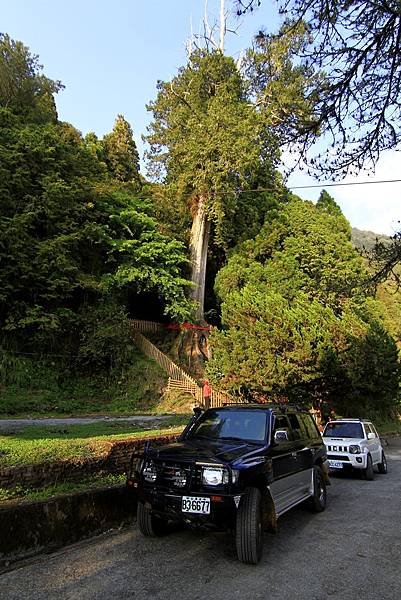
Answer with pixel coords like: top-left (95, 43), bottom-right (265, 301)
top-left (0, 447), bottom-right (401, 600)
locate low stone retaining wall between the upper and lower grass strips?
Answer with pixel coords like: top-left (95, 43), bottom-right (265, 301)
top-left (0, 434), bottom-right (177, 489)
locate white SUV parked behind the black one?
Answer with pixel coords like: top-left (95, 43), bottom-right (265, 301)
top-left (322, 419), bottom-right (387, 480)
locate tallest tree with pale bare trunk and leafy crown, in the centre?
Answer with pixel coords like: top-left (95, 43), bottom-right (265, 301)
top-left (147, 50), bottom-right (278, 320)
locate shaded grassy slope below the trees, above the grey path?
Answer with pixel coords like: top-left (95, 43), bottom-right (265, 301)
top-left (0, 351), bottom-right (167, 418)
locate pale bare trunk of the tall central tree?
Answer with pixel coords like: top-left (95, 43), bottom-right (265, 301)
top-left (190, 196), bottom-right (210, 322)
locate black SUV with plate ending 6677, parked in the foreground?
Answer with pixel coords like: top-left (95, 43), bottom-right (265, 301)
top-left (128, 404), bottom-right (328, 564)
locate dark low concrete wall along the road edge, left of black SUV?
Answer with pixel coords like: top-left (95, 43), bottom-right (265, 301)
top-left (0, 486), bottom-right (136, 572)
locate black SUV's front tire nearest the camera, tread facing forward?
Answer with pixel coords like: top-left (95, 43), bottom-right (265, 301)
top-left (235, 488), bottom-right (263, 565)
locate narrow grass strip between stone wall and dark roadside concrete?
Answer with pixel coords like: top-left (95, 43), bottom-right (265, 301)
top-left (0, 474), bottom-right (126, 503)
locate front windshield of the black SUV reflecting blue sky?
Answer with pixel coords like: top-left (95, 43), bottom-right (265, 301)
top-left (186, 409), bottom-right (267, 442)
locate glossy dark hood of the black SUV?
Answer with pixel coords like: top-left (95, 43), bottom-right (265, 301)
top-left (147, 440), bottom-right (265, 464)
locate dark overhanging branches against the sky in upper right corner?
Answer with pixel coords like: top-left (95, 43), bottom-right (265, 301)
top-left (234, 0), bottom-right (401, 177)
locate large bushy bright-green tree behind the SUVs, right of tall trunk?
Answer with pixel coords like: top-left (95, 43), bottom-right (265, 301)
top-left (208, 196), bottom-right (401, 415)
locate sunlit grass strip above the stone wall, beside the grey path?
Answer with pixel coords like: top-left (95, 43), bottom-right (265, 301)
top-left (0, 415), bottom-right (188, 468)
